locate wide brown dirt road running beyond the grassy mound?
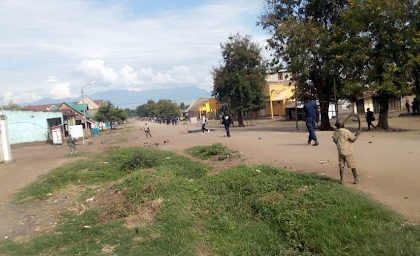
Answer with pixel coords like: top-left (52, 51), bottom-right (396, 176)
top-left (0, 118), bottom-right (420, 240)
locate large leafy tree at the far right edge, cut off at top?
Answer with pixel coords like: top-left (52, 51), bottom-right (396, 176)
top-left (344, 0), bottom-right (419, 129)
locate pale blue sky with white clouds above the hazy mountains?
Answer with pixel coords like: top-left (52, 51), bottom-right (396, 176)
top-left (0, 0), bottom-right (268, 104)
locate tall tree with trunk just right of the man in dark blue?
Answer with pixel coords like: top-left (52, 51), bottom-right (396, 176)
top-left (259, 0), bottom-right (347, 130)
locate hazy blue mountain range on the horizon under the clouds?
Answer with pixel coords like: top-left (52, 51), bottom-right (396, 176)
top-left (22, 87), bottom-right (210, 108)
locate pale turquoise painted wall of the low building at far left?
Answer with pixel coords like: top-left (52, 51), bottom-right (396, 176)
top-left (4, 110), bottom-right (63, 144)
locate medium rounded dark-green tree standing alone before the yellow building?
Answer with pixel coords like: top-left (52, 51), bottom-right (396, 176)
top-left (213, 34), bottom-right (266, 126)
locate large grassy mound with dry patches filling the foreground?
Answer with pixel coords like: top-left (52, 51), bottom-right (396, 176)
top-left (0, 148), bottom-right (420, 255)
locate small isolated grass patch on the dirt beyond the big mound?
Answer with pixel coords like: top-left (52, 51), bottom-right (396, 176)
top-left (186, 143), bottom-right (235, 161)
